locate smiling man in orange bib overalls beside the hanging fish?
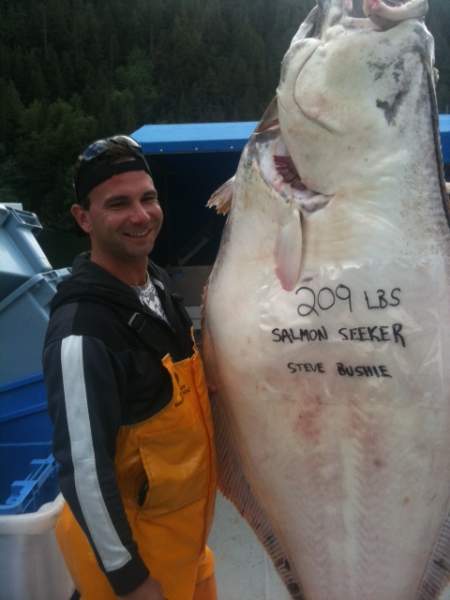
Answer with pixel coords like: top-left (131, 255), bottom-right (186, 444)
top-left (43, 136), bottom-right (216, 600)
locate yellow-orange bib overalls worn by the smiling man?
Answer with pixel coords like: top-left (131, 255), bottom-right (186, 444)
top-left (56, 349), bottom-right (216, 600)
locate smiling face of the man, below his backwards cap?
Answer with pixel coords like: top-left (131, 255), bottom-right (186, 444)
top-left (72, 171), bottom-right (163, 262)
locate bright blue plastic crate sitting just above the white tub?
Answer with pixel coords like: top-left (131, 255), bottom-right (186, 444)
top-left (0, 441), bottom-right (59, 515)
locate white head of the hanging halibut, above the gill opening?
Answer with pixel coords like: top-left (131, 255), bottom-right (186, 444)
top-left (277, 0), bottom-right (433, 196)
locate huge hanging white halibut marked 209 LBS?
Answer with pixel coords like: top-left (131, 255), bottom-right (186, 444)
top-left (204, 0), bottom-right (450, 600)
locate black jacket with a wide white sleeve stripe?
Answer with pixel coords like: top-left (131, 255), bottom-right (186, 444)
top-left (43, 255), bottom-right (193, 595)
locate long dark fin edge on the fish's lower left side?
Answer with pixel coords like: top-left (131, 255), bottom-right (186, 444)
top-left (211, 393), bottom-right (304, 600)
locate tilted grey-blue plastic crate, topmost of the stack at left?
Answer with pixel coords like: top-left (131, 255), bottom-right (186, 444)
top-left (0, 204), bottom-right (52, 300)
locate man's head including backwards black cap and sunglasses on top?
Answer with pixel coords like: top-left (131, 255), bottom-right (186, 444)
top-left (71, 136), bottom-right (163, 280)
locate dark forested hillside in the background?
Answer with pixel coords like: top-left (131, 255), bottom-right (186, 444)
top-left (0, 0), bottom-right (450, 227)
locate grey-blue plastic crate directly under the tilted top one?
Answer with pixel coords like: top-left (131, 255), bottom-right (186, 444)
top-left (0, 269), bottom-right (70, 385)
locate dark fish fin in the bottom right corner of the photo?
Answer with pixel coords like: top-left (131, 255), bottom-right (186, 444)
top-left (417, 515), bottom-right (450, 600)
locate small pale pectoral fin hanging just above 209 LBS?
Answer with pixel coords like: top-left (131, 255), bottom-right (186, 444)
top-left (275, 208), bottom-right (302, 291)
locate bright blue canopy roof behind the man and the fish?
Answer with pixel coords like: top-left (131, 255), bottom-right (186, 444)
top-left (132, 115), bottom-right (450, 164)
